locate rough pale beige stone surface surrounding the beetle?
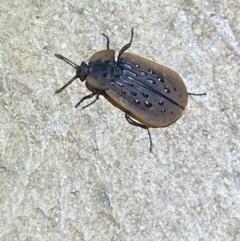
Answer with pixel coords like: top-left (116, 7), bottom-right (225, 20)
top-left (0, 0), bottom-right (240, 241)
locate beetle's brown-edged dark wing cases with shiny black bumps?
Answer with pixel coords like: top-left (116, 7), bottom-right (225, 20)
top-left (106, 52), bottom-right (188, 127)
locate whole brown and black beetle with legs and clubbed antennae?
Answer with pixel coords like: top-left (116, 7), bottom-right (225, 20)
top-left (55, 28), bottom-right (206, 152)
